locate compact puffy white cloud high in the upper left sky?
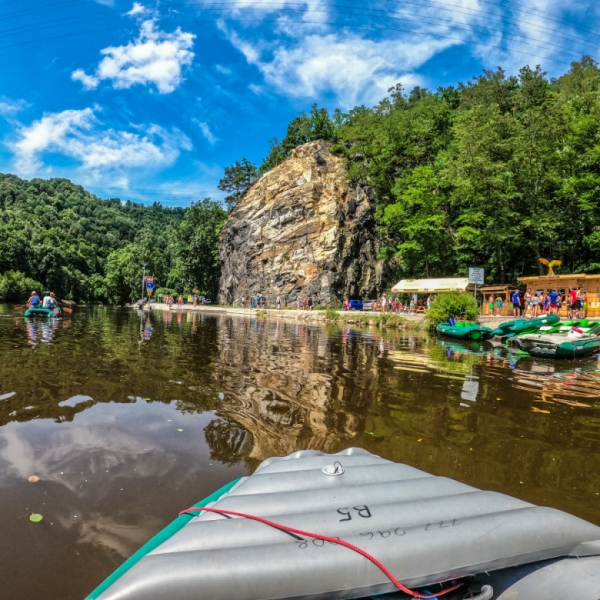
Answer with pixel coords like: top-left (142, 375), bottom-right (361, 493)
top-left (71, 19), bottom-right (195, 94)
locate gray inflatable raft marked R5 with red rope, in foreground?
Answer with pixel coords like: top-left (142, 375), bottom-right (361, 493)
top-left (88, 448), bottom-right (600, 600)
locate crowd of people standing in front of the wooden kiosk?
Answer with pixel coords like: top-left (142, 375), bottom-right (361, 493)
top-left (488, 287), bottom-right (587, 319)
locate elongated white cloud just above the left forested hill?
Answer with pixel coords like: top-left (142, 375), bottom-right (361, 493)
top-left (12, 108), bottom-right (191, 181)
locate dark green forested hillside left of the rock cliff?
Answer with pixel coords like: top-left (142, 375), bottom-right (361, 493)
top-left (0, 175), bottom-right (226, 302)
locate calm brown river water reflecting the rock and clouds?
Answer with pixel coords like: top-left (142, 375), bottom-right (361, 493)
top-left (0, 307), bottom-right (600, 600)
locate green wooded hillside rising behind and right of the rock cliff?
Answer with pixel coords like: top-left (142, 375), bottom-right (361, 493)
top-left (222, 57), bottom-right (600, 282)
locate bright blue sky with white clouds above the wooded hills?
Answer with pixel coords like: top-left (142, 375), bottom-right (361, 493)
top-left (0, 0), bottom-right (600, 206)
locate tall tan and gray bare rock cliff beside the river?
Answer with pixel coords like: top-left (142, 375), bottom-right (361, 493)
top-left (219, 141), bottom-right (382, 306)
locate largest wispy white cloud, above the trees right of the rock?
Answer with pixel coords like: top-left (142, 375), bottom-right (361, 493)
top-left (219, 0), bottom-right (600, 108)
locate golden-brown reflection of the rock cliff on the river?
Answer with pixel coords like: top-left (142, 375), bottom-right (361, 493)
top-left (215, 319), bottom-right (378, 462)
